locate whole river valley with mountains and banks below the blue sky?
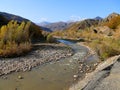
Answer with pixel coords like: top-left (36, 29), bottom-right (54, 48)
top-left (0, 12), bottom-right (120, 90)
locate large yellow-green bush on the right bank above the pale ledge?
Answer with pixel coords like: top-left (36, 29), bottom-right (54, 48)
top-left (87, 37), bottom-right (120, 60)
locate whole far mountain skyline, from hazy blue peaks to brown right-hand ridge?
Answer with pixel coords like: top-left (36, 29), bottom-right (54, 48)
top-left (37, 13), bottom-right (120, 32)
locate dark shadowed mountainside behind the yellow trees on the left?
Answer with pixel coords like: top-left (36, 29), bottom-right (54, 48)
top-left (0, 12), bottom-right (44, 40)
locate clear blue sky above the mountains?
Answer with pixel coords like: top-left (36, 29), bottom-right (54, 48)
top-left (0, 0), bottom-right (120, 23)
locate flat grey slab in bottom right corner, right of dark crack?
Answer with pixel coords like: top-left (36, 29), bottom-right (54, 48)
top-left (95, 61), bottom-right (120, 90)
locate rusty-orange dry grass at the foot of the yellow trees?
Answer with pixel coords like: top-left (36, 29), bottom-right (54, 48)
top-left (0, 42), bottom-right (31, 57)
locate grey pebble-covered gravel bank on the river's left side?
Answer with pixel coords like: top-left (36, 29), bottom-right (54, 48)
top-left (0, 44), bottom-right (73, 75)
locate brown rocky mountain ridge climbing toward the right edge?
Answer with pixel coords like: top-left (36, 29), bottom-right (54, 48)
top-left (66, 13), bottom-right (120, 31)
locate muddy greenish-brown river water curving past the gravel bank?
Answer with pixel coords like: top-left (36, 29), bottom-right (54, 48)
top-left (0, 40), bottom-right (88, 90)
